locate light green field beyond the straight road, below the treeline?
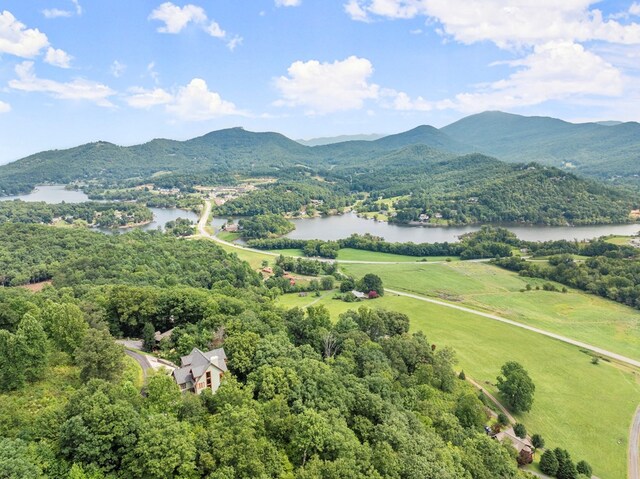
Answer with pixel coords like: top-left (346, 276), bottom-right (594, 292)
top-left (342, 261), bottom-right (640, 359)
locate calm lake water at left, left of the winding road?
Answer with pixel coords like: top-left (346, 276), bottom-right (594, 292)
top-left (0, 185), bottom-right (198, 233)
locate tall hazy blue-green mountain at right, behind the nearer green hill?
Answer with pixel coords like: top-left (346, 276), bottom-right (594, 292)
top-left (441, 111), bottom-right (640, 178)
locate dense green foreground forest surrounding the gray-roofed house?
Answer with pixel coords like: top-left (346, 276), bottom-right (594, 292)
top-left (0, 224), bottom-right (536, 479)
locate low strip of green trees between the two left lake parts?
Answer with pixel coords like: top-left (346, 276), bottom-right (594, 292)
top-left (0, 200), bottom-right (153, 228)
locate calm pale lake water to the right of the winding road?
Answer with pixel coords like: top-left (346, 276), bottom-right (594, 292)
top-left (213, 213), bottom-right (640, 243)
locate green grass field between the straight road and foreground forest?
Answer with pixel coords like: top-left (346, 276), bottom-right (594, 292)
top-left (278, 294), bottom-right (640, 479)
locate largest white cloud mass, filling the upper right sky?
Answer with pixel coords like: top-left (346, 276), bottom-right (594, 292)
top-left (344, 0), bottom-right (640, 111)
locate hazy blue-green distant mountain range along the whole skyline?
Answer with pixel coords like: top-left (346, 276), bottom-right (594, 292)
top-left (0, 112), bottom-right (640, 195)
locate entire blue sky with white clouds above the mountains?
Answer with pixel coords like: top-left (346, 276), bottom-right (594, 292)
top-left (0, 0), bottom-right (640, 163)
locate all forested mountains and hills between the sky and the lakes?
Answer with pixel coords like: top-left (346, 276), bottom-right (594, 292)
top-left (0, 112), bottom-right (640, 224)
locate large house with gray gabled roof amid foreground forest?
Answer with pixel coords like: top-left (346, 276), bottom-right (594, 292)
top-left (172, 348), bottom-right (227, 394)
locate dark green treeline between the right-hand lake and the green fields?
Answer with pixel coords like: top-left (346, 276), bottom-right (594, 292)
top-left (247, 230), bottom-right (520, 259)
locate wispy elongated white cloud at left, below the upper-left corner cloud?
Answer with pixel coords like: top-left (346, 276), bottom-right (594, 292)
top-left (9, 61), bottom-right (115, 107)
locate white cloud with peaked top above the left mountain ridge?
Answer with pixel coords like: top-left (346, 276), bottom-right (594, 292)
top-left (126, 78), bottom-right (246, 121)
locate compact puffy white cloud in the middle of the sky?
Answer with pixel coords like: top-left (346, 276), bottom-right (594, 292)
top-left (275, 56), bottom-right (379, 114)
